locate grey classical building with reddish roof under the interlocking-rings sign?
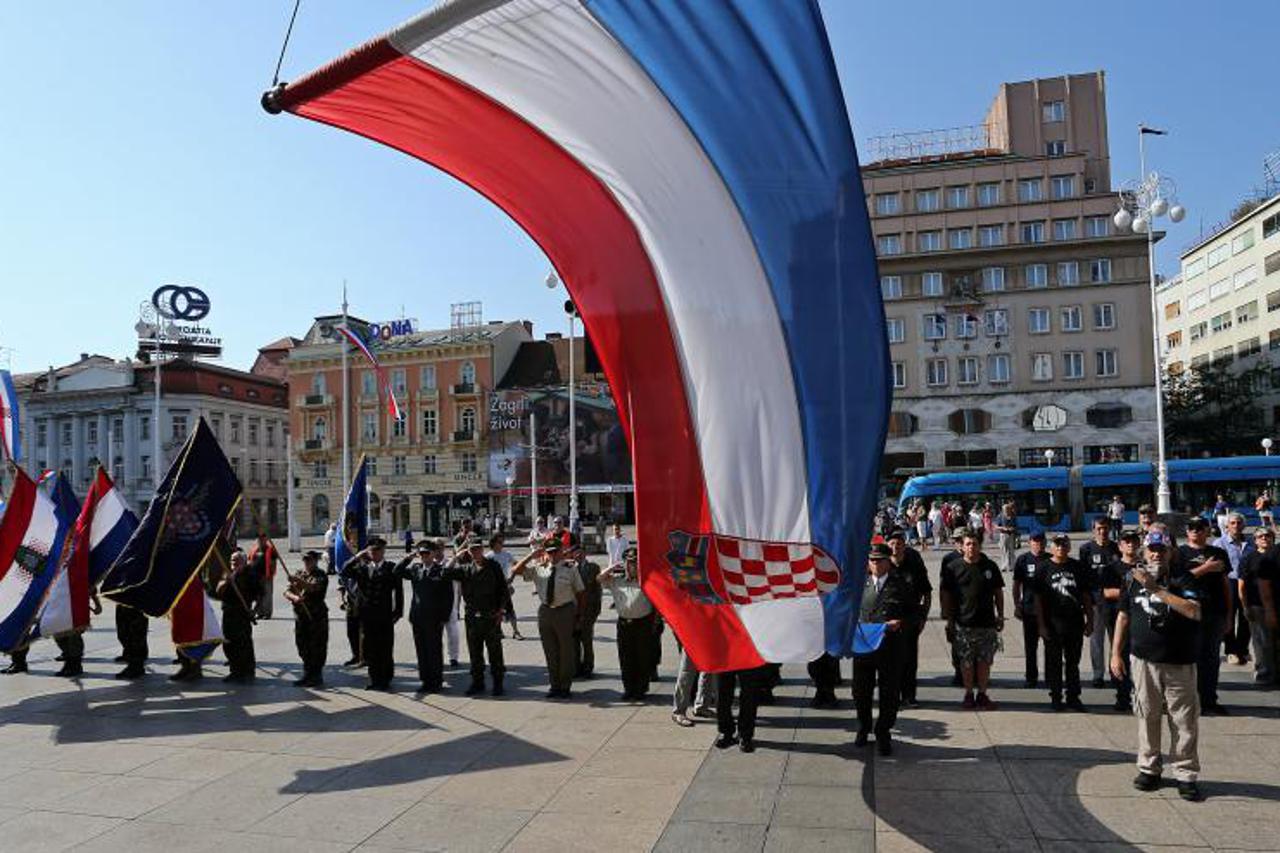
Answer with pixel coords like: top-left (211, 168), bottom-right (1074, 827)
top-left (15, 353), bottom-right (288, 533)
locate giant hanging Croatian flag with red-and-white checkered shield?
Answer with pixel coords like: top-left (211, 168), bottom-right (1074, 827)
top-left (264, 0), bottom-right (890, 671)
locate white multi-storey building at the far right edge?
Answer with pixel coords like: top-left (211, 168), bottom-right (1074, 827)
top-left (1157, 196), bottom-right (1280, 424)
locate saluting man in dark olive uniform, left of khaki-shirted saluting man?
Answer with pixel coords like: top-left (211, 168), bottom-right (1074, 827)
top-left (444, 539), bottom-right (509, 695)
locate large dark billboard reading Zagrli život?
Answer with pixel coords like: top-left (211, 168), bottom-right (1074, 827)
top-left (489, 383), bottom-right (631, 493)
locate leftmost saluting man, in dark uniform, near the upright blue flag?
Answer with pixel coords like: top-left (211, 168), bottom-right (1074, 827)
top-left (342, 537), bottom-right (404, 690)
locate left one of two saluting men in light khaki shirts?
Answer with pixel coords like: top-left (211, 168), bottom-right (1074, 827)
top-left (512, 537), bottom-right (585, 699)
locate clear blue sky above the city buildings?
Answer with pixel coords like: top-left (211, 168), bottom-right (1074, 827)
top-left (0, 0), bottom-right (1280, 370)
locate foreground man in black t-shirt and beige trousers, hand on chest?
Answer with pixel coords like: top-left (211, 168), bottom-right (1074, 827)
top-left (1111, 530), bottom-right (1201, 799)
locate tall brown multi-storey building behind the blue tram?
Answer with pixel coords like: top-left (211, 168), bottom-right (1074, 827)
top-left (863, 72), bottom-right (1155, 478)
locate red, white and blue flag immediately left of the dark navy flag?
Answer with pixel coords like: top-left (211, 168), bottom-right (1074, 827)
top-left (36, 467), bottom-right (138, 637)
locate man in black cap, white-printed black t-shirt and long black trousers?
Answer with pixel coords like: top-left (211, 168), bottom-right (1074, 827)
top-left (1036, 533), bottom-right (1094, 711)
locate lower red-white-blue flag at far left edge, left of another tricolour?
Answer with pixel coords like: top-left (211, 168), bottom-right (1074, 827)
top-left (0, 469), bottom-right (79, 652)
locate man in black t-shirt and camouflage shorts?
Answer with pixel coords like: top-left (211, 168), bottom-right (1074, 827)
top-left (940, 530), bottom-right (1005, 711)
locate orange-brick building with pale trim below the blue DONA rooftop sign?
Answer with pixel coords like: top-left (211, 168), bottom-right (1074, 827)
top-left (285, 315), bottom-right (532, 534)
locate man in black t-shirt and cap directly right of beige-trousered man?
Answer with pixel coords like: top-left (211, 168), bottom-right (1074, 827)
top-left (1178, 519), bottom-right (1233, 716)
